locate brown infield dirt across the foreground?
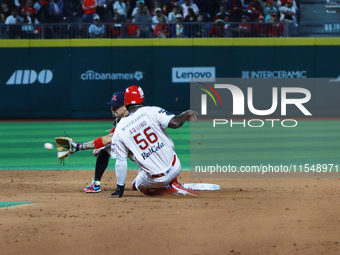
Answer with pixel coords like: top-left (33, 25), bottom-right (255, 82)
top-left (0, 171), bottom-right (340, 255)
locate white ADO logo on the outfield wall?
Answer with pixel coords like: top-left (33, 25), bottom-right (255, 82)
top-left (6, 69), bottom-right (53, 85)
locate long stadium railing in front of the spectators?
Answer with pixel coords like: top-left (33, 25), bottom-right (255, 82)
top-left (0, 22), bottom-right (340, 39)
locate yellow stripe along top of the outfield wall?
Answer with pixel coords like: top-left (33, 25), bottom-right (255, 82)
top-left (0, 37), bottom-right (340, 48)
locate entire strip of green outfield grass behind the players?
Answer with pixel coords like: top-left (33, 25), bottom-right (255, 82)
top-left (0, 121), bottom-right (340, 170)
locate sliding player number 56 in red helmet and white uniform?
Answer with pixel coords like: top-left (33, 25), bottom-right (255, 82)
top-left (111, 86), bottom-right (198, 197)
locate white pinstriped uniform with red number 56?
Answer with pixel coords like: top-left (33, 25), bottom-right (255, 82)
top-left (111, 106), bottom-right (181, 189)
